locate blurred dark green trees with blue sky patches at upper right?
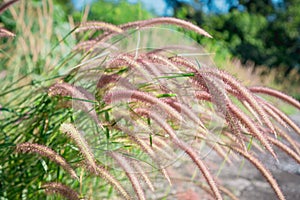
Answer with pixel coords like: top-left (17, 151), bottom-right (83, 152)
top-left (166, 0), bottom-right (300, 74)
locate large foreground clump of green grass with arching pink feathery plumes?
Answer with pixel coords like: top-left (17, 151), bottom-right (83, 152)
top-left (0, 1), bottom-right (300, 199)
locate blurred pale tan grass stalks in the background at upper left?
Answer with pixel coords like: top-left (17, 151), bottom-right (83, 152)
top-left (0, 0), bottom-right (78, 104)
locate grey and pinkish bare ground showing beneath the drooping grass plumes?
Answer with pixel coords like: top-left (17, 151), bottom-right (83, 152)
top-left (154, 112), bottom-right (300, 200)
